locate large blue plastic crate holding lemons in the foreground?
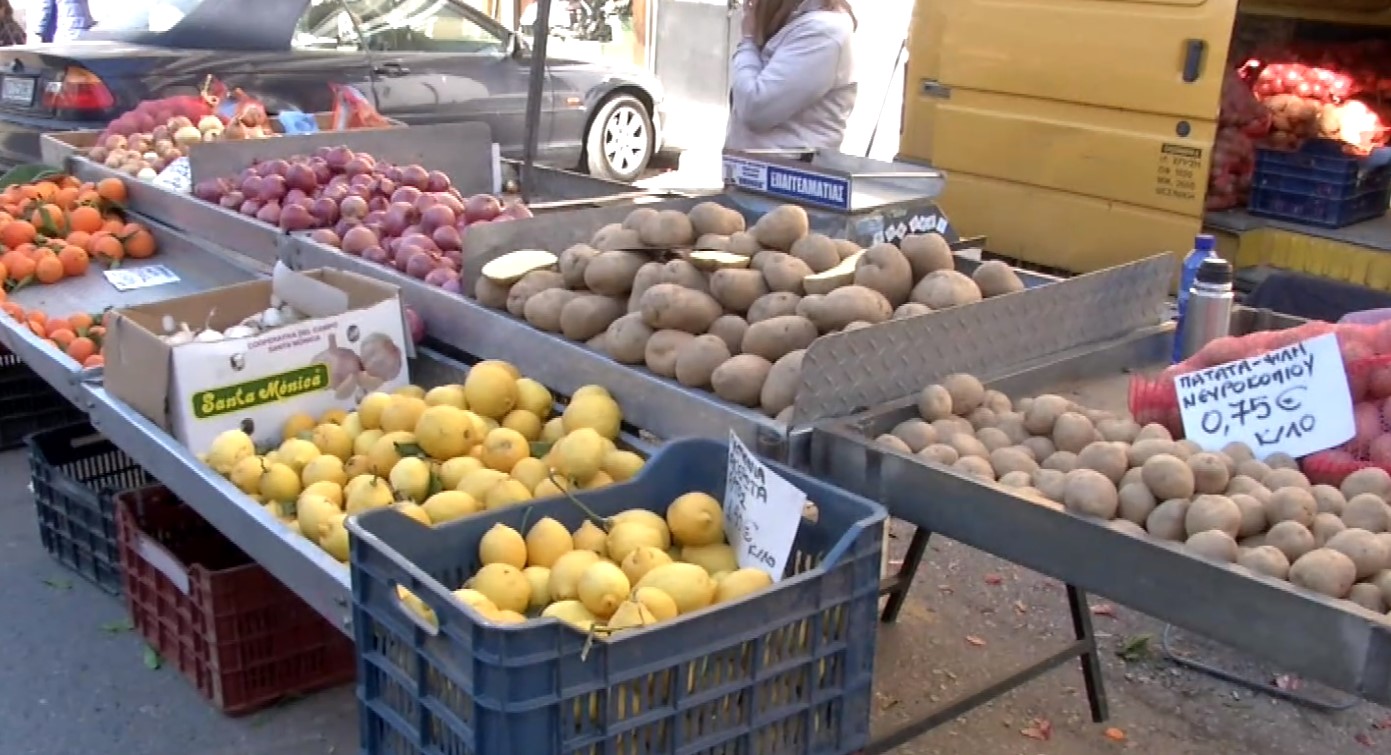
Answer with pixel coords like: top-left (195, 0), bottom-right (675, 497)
top-left (349, 439), bottom-right (886, 755)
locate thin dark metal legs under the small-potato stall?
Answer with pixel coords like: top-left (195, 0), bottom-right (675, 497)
top-left (858, 527), bottom-right (1110, 755)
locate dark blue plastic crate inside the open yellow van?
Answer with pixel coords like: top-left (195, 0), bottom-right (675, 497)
top-left (1248, 139), bottom-right (1391, 228)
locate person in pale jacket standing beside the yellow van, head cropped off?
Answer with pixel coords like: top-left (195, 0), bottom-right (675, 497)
top-left (725, 0), bottom-right (858, 150)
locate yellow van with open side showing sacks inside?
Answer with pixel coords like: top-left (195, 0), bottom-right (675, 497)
top-left (900, 0), bottom-right (1391, 291)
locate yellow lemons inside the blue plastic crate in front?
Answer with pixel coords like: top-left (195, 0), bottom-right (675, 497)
top-left (398, 492), bottom-right (772, 633)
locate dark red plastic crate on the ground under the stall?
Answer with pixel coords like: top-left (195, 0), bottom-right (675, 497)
top-left (115, 485), bottom-right (356, 716)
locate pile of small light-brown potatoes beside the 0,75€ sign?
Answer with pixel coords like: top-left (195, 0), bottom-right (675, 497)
top-left (876, 374), bottom-right (1391, 619)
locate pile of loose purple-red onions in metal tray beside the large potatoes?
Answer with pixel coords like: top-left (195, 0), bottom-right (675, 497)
top-left (193, 146), bottom-right (531, 292)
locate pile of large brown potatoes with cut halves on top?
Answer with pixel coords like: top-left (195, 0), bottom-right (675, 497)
top-left (474, 202), bottom-right (1024, 421)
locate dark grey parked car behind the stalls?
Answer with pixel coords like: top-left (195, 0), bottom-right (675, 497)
top-left (0, 0), bottom-right (662, 181)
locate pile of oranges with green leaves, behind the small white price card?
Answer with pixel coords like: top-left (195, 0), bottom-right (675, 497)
top-left (0, 175), bottom-right (154, 293)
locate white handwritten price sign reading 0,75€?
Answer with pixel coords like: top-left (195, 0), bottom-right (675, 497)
top-left (1174, 334), bottom-right (1356, 459)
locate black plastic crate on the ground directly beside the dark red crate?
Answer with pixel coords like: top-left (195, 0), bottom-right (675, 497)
top-left (25, 421), bottom-right (154, 595)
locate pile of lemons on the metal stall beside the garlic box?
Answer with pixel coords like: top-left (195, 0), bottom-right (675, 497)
top-left (200, 360), bottom-right (643, 562)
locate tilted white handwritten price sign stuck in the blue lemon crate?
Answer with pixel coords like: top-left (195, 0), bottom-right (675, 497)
top-left (723, 432), bottom-right (807, 581)
